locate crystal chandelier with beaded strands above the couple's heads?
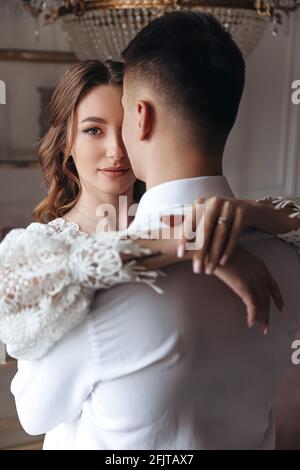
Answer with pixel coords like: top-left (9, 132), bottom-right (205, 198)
top-left (22, 0), bottom-right (300, 60)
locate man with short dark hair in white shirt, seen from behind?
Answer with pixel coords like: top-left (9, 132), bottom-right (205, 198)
top-left (11, 12), bottom-right (300, 450)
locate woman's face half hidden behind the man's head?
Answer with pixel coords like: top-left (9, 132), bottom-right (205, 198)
top-left (71, 85), bottom-right (135, 196)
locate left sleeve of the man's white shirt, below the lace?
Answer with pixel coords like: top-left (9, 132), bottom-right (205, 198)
top-left (11, 322), bottom-right (95, 435)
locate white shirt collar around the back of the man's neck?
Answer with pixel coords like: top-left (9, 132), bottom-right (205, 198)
top-left (135, 176), bottom-right (234, 222)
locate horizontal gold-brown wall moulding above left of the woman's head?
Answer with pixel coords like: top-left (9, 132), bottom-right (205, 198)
top-left (0, 49), bottom-right (78, 64)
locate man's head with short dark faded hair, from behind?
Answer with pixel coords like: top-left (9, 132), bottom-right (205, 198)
top-left (123, 11), bottom-right (245, 184)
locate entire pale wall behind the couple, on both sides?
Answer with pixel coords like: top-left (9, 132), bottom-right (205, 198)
top-left (0, 5), bottom-right (300, 226)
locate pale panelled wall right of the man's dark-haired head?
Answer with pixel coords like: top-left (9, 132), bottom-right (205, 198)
top-left (225, 10), bottom-right (300, 197)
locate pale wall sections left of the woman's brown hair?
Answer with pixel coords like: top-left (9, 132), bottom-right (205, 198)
top-left (0, 0), bottom-right (70, 228)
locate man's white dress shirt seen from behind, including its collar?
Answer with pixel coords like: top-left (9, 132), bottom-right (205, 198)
top-left (12, 176), bottom-right (300, 450)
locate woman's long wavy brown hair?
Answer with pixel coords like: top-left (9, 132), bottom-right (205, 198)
top-left (32, 60), bottom-right (145, 223)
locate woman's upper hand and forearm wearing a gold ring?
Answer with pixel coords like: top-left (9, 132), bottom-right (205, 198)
top-left (178, 197), bottom-right (300, 274)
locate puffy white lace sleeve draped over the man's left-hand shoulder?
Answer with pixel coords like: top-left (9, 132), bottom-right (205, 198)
top-left (0, 220), bottom-right (162, 360)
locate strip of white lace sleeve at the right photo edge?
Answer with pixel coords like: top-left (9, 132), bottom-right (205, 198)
top-left (257, 196), bottom-right (300, 261)
